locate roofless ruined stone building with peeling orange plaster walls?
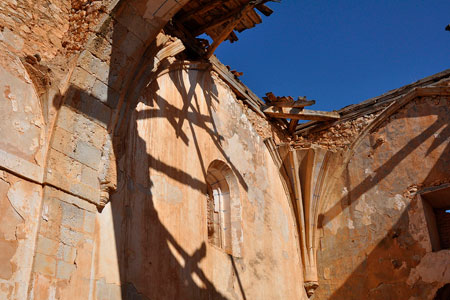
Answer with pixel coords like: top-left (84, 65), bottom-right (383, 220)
top-left (0, 0), bottom-right (450, 300)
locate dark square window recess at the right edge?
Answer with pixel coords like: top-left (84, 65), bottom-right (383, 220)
top-left (420, 184), bottom-right (450, 251)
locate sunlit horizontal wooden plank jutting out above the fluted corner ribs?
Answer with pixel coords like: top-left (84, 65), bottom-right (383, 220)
top-left (263, 106), bottom-right (340, 121)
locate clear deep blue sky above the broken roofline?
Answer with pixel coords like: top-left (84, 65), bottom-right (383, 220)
top-left (215, 0), bottom-right (450, 110)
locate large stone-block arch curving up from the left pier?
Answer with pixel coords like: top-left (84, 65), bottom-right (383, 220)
top-left (43, 0), bottom-right (187, 209)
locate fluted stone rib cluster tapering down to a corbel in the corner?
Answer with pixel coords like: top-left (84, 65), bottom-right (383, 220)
top-left (278, 145), bottom-right (337, 297)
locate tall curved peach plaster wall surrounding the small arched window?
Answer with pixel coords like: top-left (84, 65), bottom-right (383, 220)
top-left (92, 63), bottom-right (306, 299)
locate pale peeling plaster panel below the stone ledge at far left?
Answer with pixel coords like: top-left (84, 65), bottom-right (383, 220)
top-left (0, 170), bottom-right (42, 299)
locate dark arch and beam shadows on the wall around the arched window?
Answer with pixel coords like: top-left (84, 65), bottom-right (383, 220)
top-left (54, 1), bottom-right (247, 300)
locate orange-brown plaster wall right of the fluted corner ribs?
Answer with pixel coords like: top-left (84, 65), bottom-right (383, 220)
top-left (315, 96), bottom-right (450, 300)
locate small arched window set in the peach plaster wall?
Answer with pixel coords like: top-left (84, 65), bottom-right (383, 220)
top-left (206, 160), bottom-right (242, 257)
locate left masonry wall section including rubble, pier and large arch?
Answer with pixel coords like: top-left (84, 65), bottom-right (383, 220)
top-left (0, 0), bottom-right (192, 299)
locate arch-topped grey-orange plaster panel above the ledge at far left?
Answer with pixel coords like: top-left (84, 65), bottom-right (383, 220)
top-left (0, 49), bottom-right (48, 183)
